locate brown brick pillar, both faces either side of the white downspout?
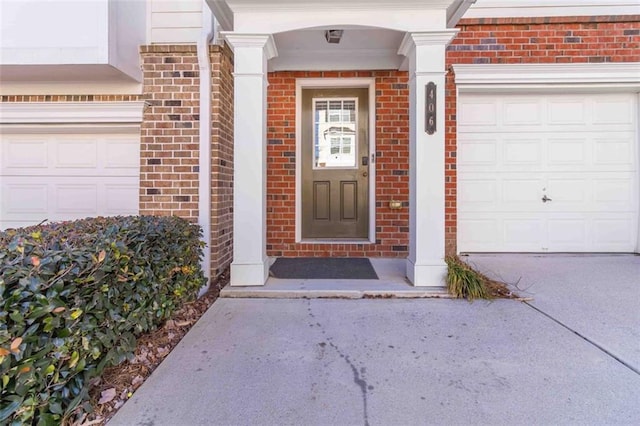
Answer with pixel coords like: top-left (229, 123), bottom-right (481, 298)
top-left (140, 45), bottom-right (233, 276)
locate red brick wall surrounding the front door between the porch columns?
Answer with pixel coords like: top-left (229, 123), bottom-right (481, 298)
top-left (267, 71), bottom-right (409, 257)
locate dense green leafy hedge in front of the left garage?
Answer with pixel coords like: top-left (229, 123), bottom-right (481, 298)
top-left (0, 216), bottom-right (205, 424)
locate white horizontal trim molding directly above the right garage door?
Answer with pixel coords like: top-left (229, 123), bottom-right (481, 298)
top-left (453, 62), bottom-right (640, 91)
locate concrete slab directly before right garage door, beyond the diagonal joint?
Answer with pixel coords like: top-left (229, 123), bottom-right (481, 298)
top-left (466, 254), bottom-right (640, 374)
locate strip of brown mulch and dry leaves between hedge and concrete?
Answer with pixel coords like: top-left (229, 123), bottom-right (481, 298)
top-left (73, 270), bottom-right (229, 426)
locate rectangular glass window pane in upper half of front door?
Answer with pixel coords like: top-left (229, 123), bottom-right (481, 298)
top-left (313, 99), bottom-right (357, 169)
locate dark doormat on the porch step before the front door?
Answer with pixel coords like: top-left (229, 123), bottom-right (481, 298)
top-left (271, 257), bottom-right (378, 280)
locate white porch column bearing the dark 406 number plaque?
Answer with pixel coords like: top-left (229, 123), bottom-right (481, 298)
top-left (399, 30), bottom-right (457, 287)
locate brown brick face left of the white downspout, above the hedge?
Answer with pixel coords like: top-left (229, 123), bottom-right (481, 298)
top-left (140, 45), bottom-right (200, 223)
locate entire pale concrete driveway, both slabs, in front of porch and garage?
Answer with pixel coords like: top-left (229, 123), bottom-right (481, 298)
top-left (110, 256), bottom-right (640, 425)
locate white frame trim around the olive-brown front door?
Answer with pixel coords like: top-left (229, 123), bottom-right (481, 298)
top-left (295, 77), bottom-right (376, 244)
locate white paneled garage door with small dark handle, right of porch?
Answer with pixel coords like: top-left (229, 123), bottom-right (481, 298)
top-left (457, 94), bottom-right (640, 252)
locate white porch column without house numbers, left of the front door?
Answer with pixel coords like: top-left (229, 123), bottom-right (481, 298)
top-left (223, 32), bottom-right (277, 286)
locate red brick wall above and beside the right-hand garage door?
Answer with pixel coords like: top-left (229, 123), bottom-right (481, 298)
top-left (445, 16), bottom-right (640, 253)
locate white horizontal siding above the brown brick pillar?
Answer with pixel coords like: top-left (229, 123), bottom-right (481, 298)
top-left (149, 0), bottom-right (202, 43)
